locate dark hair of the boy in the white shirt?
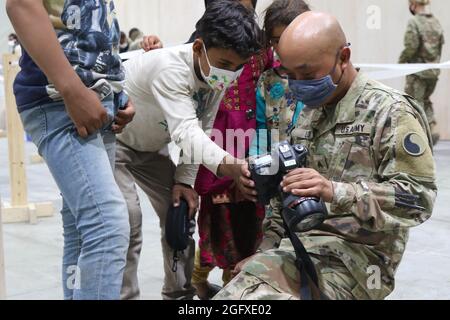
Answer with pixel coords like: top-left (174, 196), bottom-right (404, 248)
top-left (195, 0), bottom-right (263, 59)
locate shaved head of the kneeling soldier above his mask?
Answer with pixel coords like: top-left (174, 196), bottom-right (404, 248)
top-left (278, 11), bottom-right (357, 102)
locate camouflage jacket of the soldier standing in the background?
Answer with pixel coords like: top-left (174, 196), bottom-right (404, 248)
top-left (399, 14), bottom-right (444, 79)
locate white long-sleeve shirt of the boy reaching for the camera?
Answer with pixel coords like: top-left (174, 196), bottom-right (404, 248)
top-left (118, 44), bottom-right (228, 185)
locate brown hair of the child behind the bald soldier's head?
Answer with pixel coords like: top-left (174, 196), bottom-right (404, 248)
top-left (264, 0), bottom-right (311, 46)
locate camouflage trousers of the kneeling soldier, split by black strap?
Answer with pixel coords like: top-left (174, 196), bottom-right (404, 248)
top-left (214, 249), bottom-right (370, 300)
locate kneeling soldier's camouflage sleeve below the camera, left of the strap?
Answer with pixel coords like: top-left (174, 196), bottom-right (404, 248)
top-left (259, 197), bottom-right (285, 251)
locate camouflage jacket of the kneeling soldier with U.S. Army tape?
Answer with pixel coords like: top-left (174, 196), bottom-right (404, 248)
top-left (260, 74), bottom-right (437, 299)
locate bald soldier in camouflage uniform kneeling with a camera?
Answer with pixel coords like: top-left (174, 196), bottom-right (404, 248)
top-left (215, 12), bottom-right (437, 300)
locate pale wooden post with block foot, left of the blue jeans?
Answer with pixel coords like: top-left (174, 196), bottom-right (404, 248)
top-left (3, 54), bottom-right (54, 223)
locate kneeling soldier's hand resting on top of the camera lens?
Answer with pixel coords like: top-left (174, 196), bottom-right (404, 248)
top-left (281, 168), bottom-right (334, 203)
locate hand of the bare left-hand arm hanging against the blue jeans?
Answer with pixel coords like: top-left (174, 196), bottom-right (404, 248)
top-left (61, 82), bottom-right (112, 138)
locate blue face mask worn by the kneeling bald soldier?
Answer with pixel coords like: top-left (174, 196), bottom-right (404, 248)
top-left (289, 45), bottom-right (344, 108)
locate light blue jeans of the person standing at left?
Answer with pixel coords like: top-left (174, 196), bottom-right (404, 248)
top-left (21, 100), bottom-right (130, 300)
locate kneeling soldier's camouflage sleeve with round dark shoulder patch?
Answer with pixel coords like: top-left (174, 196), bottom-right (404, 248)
top-left (331, 102), bottom-right (437, 232)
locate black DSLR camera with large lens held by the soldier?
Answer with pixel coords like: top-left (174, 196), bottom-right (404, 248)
top-left (249, 141), bottom-right (328, 232)
